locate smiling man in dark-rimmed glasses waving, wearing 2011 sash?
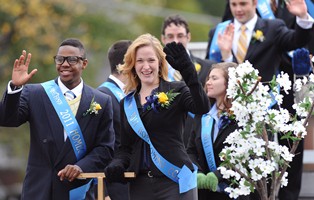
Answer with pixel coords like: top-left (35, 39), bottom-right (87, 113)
top-left (0, 38), bottom-right (114, 200)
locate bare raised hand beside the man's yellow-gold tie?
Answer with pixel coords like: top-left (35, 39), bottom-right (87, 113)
top-left (217, 23), bottom-right (234, 60)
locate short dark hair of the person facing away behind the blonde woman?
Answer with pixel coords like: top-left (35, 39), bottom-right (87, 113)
top-left (108, 40), bottom-right (132, 74)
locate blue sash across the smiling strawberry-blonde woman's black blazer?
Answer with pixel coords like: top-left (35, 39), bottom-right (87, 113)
top-left (124, 93), bottom-right (197, 193)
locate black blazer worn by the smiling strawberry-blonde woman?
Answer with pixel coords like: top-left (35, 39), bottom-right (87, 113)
top-left (115, 79), bottom-right (209, 176)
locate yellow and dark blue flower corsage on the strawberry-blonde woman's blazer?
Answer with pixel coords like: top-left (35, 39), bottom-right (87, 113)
top-left (143, 90), bottom-right (179, 113)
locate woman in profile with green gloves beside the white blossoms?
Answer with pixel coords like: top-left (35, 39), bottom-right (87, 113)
top-left (187, 62), bottom-right (246, 200)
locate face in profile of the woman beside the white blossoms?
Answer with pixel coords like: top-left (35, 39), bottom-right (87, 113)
top-left (205, 68), bottom-right (227, 101)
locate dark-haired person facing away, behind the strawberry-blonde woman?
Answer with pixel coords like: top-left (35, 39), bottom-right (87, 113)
top-left (98, 40), bottom-right (132, 200)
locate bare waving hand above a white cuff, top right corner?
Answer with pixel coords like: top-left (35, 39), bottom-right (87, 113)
top-left (285, 0), bottom-right (307, 19)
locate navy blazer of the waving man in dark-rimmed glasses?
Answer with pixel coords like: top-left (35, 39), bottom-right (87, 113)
top-left (0, 79), bottom-right (114, 200)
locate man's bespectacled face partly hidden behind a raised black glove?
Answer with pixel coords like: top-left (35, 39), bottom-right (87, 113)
top-left (161, 23), bottom-right (191, 48)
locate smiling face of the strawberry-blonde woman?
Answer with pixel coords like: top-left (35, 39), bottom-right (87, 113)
top-left (135, 46), bottom-right (159, 85)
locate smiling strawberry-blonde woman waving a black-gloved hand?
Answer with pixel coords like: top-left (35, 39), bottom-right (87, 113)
top-left (105, 34), bottom-right (209, 200)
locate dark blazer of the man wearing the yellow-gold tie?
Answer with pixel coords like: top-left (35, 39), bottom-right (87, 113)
top-left (207, 18), bottom-right (313, 82)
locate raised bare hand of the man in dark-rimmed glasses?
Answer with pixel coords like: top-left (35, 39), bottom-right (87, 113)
top-left (12, 50), bottom-right (37, 86)
